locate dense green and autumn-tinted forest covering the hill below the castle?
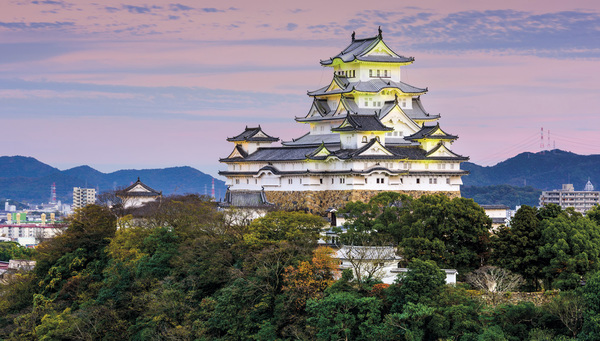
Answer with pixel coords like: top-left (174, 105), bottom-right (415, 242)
top-left (0, 193), bottom-right (600, 340)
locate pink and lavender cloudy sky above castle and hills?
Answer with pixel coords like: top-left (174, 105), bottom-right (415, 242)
top-left (0, 0), bottom-right (600, 176)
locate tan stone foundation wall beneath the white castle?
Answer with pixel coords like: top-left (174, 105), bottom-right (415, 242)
top-left (265, 190), bottom-right (460, 214)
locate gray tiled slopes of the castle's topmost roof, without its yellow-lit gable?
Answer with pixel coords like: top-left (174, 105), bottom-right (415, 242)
top-left (321, 34), bottom-right (414, 66)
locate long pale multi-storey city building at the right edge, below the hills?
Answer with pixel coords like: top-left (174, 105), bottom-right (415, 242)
top-left (540, 180), bottom-right (600, 213)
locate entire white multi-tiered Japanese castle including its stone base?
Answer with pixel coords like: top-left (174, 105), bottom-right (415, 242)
top-left (219, 29), bottom-right (468, 213)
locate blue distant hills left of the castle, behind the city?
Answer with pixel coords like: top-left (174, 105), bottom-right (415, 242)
top-left (0, 156), bottom-right (226, 203)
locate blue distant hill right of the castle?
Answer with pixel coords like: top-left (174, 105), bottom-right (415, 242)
top-left (461, 149), bottom-right (600, 190)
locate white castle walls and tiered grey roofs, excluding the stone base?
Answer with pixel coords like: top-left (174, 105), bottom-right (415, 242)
top-left (220, 29), bottom-right (468, 202)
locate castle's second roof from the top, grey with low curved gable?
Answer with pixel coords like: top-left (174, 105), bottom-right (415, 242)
top-left (307, 78), bottom-right (428, 96)
